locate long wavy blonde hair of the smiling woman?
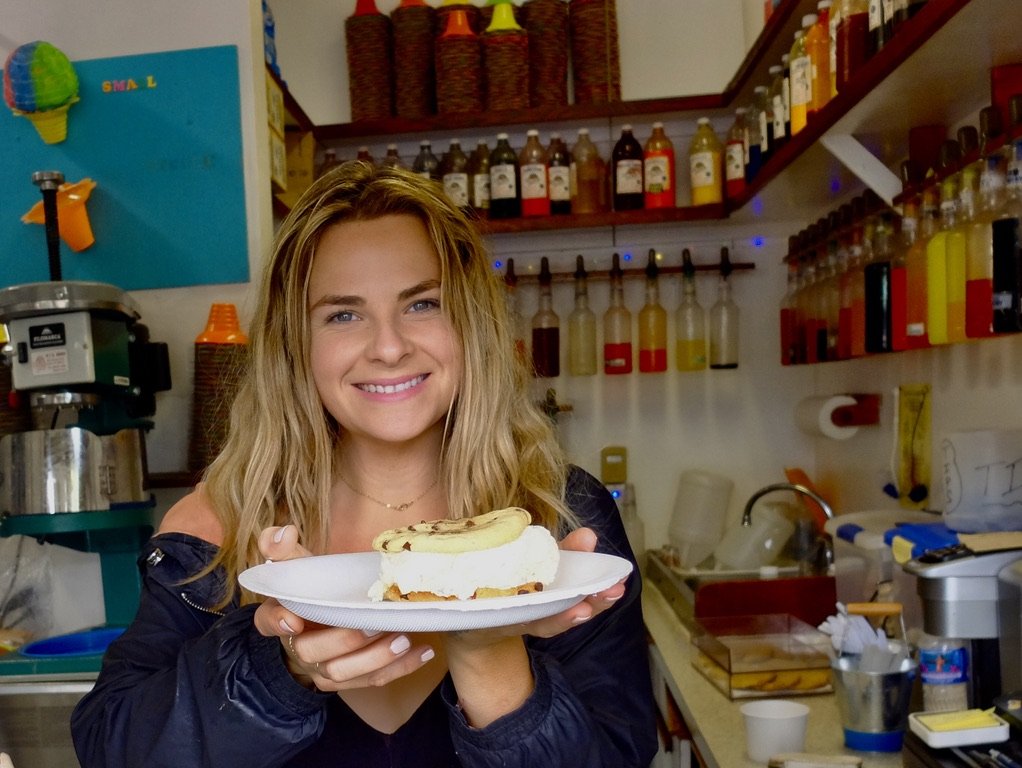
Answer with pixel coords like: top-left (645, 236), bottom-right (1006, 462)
top-left (202, 163), bottom-right (577, 606)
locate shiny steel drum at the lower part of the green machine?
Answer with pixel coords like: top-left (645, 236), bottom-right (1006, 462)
top-left (0, 426), bottom-right (148, 514)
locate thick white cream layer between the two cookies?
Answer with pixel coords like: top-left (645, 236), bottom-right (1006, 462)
top-left (369, 526), bottom-right (560, 601)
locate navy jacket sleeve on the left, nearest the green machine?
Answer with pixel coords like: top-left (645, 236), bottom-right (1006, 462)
top-left (72, 535), bottom-right (328, 768)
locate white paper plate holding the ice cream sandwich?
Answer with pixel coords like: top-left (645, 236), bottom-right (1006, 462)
top-left (238, 551), bottom-right (632, 632)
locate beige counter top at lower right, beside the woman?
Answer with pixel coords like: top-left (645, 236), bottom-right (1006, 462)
top-left (642, 582), bottom-right (902, 768)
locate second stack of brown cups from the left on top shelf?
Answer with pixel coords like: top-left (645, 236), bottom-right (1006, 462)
top-left (390, 5), bottom-right (434, 118)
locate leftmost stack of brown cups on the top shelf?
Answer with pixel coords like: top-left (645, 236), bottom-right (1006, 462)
top-left (344, 13), bottom-right (393, 122)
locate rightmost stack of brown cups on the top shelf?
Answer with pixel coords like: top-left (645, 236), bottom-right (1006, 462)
top-left (568, 0), bottom-right (621, 104)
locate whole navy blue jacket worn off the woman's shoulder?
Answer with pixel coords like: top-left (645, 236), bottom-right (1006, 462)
top-left (72, 468), bottom-right (657, 768)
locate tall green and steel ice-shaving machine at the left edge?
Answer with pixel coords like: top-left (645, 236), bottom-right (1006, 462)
top-left (0, 172), bottom-right (171, 768)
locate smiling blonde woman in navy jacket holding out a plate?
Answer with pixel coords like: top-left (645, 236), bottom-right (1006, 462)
top-left (72, 163), bottom-right (656, 768)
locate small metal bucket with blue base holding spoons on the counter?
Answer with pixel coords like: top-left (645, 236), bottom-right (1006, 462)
top-left (832, 656), bottom-right (916, 752)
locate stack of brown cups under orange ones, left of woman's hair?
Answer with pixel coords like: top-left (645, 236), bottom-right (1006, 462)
top-left (188, 344), bottom-right (248, 472)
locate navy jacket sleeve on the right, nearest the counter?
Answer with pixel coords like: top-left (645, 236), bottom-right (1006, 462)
top-left (444, 469), bottom-right (657, 768)
